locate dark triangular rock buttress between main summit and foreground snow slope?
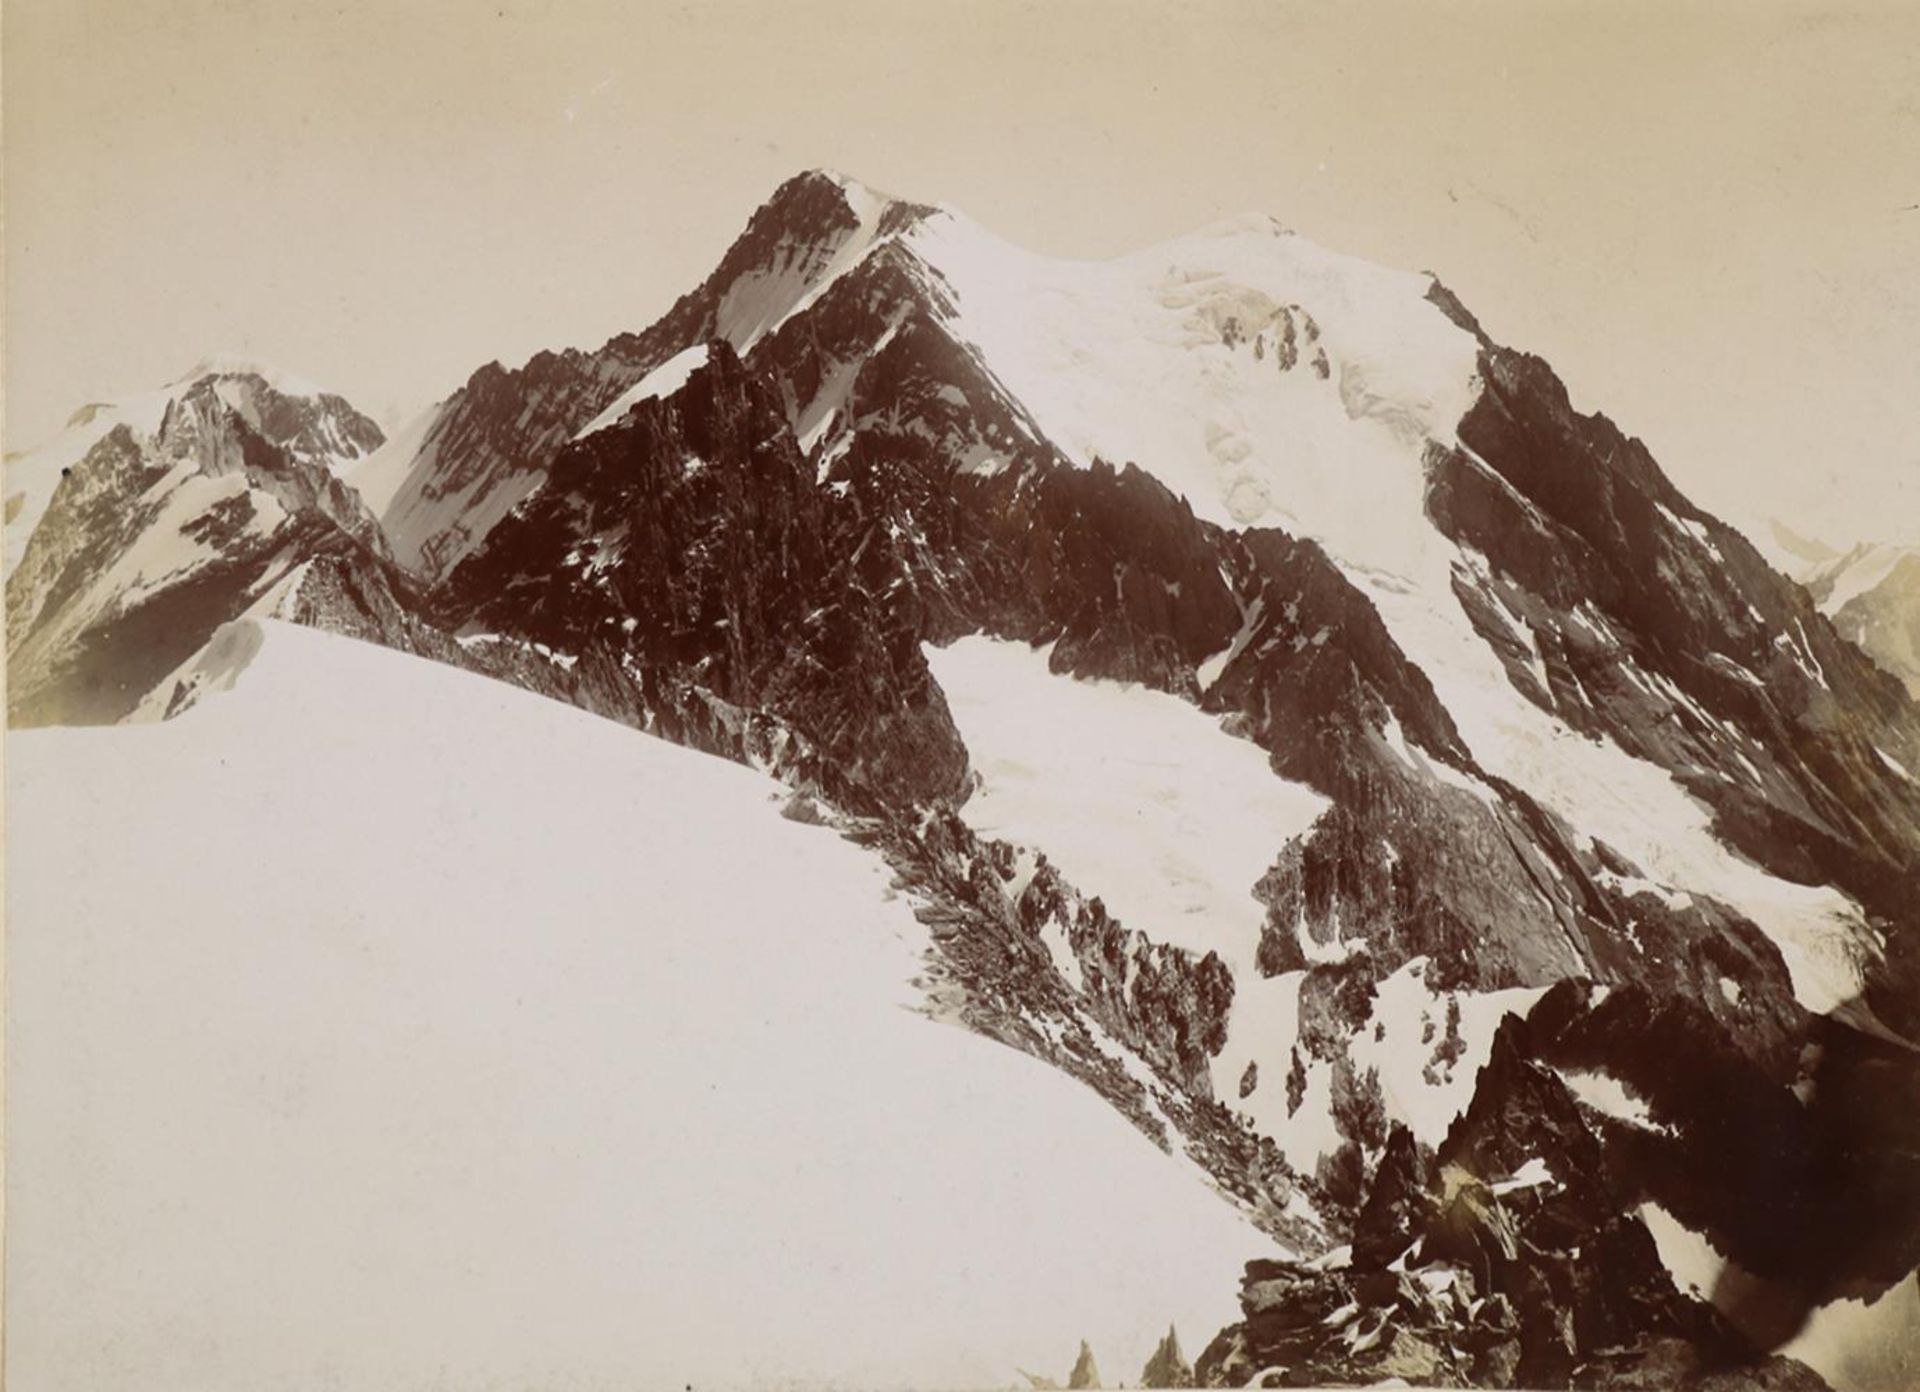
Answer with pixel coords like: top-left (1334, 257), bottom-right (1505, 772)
top-left (442, 340), bottom-right (968, 812)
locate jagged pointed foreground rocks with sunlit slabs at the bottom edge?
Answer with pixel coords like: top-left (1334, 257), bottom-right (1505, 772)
top-left (1196, 1020), bottom-right (1824, 1390)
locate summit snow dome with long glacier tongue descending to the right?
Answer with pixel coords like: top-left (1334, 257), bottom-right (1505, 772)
top-left (904, 209), bottom-right (1874, 1012)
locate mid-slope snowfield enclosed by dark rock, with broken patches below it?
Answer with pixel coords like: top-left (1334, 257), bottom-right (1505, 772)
top-left (925, 637), bottom-right (1542, 1173)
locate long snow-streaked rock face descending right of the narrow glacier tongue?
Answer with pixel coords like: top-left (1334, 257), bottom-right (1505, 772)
top-left (1428, 307), bottom-right (1920, 1010)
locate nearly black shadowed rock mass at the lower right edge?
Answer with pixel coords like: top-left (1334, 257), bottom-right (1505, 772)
top-left (1521, 977), bottom-right (1920, 1342)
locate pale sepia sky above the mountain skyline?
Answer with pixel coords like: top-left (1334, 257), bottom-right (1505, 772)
top-left (4, 0), bottom-right (1920, 540)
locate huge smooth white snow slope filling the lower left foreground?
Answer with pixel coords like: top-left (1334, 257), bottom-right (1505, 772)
top-left (6, 622), bottom-right (1269, 1392)
